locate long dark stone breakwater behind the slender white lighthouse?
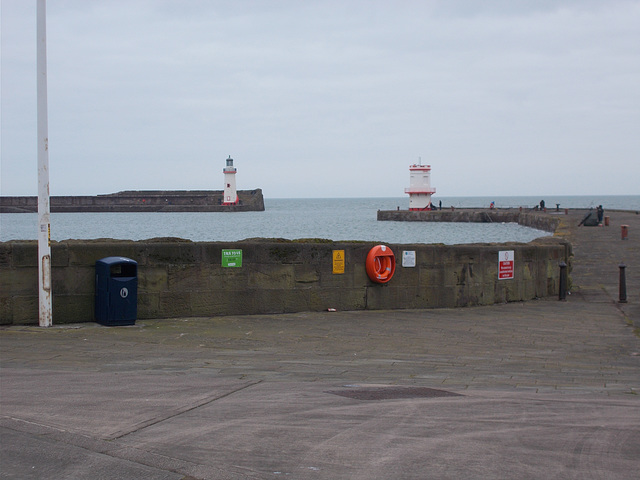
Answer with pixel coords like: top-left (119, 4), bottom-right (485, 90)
top-left (0, 188), bottom-right (264, 213)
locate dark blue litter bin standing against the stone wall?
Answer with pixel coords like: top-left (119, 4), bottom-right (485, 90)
top-left (95, 257), bottom-right (138, 326)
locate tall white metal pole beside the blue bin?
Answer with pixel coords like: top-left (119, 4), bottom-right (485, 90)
top-left (36, 0), bottom-right (53, 327)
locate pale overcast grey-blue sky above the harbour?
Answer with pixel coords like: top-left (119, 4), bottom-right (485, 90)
top-left (0, 0), bottom-right (640, 200)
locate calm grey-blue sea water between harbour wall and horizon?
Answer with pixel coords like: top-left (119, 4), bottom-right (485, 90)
top-left (0, 195), bottom-right (640, 245)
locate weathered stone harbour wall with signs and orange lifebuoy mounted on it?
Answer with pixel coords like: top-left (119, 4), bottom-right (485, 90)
top-left (0, 238), bottom-right (571, 324)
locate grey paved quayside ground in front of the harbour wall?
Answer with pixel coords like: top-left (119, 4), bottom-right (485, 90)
top-left (0, 208), bottom-right (640, 480)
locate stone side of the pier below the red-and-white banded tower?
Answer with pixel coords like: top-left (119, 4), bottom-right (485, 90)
top-left (378, 208), bottom-right (559, 232)
